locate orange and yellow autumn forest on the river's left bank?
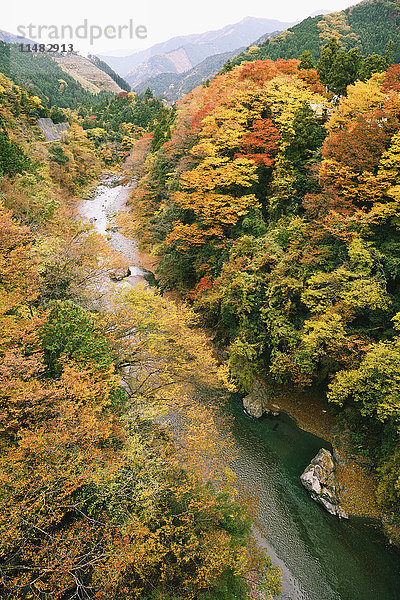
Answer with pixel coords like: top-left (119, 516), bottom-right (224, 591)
top-left (0, 55), bottom-right (280, 600)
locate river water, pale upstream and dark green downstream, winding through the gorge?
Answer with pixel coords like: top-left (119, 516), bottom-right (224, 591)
top-left (79, 178), bottom-right (400, 600)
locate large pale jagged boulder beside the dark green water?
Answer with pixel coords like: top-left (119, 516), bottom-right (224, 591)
top-left (300, 448), bottom-right (349, 519)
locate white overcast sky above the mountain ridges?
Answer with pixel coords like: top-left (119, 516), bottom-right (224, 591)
top-left (0, 0), bottom-right (357, 54)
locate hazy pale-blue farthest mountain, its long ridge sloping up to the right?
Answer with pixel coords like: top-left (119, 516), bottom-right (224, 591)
top-left (100, 17), bottom-right (291, 78)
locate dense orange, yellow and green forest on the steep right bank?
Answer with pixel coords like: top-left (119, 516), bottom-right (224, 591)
top-left (125, 56), bottom-right (400, 542)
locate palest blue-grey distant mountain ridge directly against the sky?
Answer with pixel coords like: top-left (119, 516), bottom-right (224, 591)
top-left (99, 17), bottom-right (292, 85)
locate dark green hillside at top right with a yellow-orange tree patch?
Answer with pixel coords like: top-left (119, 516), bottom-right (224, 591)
top-left (234, 0), bottom-right (400, 64)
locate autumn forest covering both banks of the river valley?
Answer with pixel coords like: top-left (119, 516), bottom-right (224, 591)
top-left (0, 0), bottom-right (400, 600)
